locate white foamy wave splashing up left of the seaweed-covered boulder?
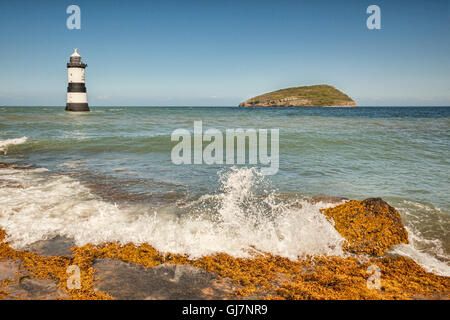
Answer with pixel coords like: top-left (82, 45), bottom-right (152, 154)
top-left (0, 169), bottom-right (344, 259)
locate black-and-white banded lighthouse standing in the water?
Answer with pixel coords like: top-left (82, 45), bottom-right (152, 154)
top-left (66, 48), bottom-right (89, 111)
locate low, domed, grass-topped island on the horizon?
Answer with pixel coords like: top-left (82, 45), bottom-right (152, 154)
top-left (239, 84), bottom-right (357, 107)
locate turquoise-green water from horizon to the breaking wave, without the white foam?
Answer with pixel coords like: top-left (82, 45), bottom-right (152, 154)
top-left (0, 107), bottom-right (450, 276)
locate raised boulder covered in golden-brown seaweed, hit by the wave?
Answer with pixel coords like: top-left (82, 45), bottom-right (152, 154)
top-left (322, 198), bottom-right (408, 256)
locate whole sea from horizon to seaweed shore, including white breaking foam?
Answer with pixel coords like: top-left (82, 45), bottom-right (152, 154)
top-left (0, 106), bottom-right (450, 276)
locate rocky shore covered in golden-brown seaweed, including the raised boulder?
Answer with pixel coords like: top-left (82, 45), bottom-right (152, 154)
top-left (0, 195), bottom-right (450, 300)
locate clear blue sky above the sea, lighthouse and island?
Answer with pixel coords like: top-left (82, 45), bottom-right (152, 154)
top-left (0, 0), bottom-right (450, 106)
